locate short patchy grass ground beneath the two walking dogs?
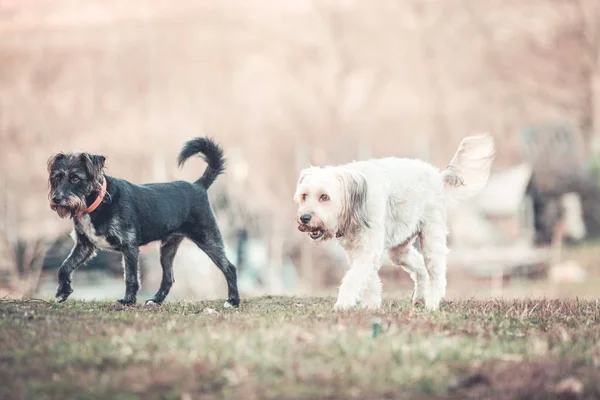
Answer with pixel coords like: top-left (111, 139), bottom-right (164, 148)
top-left (0, 297), bottom-right (600, 400)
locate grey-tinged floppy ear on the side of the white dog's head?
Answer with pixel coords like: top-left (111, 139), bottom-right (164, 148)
top-left (338, 169), bottom-right (369, 232)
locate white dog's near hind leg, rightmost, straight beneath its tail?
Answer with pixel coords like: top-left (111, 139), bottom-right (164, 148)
top-left (421, 219), bottom-right (448, 310)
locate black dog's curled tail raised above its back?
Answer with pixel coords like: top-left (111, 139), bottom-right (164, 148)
top-left (177, 137), bottom-right (225, 189)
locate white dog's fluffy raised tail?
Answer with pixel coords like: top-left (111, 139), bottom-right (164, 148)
top-left (442, 134), bottom-right (496, 201)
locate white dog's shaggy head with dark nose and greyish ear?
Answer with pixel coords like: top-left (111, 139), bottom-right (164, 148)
top-left (294, 167), bottom-right (369, 240)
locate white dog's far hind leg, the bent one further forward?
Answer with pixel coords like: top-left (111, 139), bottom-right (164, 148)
top-left (388, 243), bottom-right (430, 305)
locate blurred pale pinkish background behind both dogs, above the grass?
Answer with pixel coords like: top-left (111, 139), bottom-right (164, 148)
top-left (0, 0), bottom-right (600, 299)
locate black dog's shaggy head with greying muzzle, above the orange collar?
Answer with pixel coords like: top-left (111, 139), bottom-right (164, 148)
top-left (48, 153), bottom-right (105, 218)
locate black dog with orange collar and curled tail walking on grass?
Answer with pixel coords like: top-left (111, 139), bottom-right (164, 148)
top-left (48, 138), bottom-right (240, 307)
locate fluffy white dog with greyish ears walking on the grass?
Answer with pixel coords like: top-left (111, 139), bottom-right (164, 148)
top-left (294, 135), bottom-right (495, 310)
